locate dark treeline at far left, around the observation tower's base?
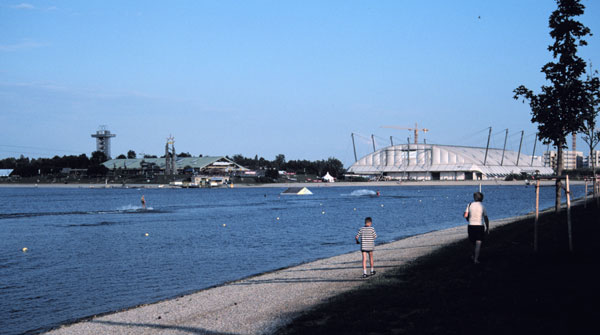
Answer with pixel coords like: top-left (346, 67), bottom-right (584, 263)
top-left (0, 151), bottom-right (108, 178)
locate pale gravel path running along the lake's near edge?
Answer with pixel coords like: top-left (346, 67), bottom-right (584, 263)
top-left (47, 216), bottom-right (524, 335)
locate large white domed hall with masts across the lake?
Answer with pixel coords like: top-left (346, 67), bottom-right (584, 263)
top-left (348, 144), bottom-right (554, 180)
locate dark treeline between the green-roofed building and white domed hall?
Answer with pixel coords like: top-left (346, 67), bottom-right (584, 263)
top-left (230, 154), bottom-right (346, 178)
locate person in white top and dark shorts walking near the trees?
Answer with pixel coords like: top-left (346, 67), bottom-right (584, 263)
top-left (464, 192), bottom-right (490, 264)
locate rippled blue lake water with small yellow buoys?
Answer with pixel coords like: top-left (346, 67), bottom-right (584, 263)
top-left (0, 186), bottom-right (584, 334)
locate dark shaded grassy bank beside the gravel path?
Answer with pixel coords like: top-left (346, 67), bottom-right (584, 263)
top-left (280, 203), bottom-right (600, 335)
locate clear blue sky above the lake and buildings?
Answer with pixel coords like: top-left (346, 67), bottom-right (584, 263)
top-left (0, 0), bottom-right (600, 166)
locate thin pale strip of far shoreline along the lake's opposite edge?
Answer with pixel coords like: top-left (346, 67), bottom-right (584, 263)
top-left (0, 180), bottom-right (585, 189)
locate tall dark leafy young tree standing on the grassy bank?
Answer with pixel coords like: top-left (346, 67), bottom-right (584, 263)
top-left (513, 0), bottom-right (590, 212)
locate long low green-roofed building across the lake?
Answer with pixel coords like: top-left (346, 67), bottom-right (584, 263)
top-left (102, 156), bottom-right (248, 175)
